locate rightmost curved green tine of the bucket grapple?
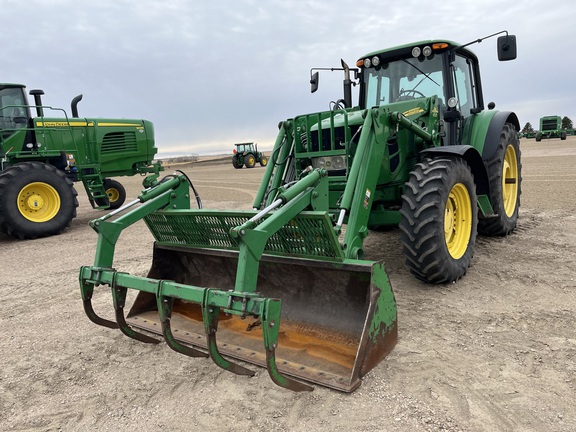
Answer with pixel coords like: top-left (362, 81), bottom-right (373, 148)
top-left (261, 298), bottom-right (314, 392)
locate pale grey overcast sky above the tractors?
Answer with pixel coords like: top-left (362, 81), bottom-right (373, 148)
top-left (0, 0), bottom-right (576, 157)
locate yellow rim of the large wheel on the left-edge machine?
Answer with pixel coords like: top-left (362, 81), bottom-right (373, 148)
top-left (18, 182), bottom-right (61, 223)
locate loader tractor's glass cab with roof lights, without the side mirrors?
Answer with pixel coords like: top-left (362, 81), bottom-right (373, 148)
top-left (357, 41), bottom-right (484, 145)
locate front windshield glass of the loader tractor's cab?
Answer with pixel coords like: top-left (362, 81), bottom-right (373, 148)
top-left (364, 55), bottom-right (444, 108)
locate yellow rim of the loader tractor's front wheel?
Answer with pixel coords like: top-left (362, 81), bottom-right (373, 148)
top-left (444, 183), bottom-right (472, 259)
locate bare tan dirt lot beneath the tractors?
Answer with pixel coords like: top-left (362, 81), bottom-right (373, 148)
top-left (0, 137), bottom-right (576, 431)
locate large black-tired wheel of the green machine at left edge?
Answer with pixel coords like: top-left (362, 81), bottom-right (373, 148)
top-left (0, 162), bottom-right (78, 240)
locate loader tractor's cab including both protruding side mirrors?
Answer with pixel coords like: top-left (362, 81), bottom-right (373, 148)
top-left (310, 32), bottom-right (517, 145)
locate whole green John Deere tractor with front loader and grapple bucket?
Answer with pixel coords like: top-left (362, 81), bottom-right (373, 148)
top-left (80, 32), bottom-right (521, 392)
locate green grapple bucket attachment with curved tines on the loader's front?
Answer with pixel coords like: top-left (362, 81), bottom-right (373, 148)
top-left (80, 171), bottom-right (397, 392)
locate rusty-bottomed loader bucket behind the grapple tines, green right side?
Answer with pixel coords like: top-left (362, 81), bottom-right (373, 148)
top-left (126, 242), bottom-right (397, 392)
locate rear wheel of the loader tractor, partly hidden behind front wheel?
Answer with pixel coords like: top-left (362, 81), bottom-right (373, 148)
top-left (478, 123), bottom-right (522, 236)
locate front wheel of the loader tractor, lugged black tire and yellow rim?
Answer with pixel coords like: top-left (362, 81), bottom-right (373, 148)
top-left (400, 157), bottom-right (478, 284)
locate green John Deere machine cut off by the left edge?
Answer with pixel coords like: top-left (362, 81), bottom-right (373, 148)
top-left (0, 84), bottom-right (162, 239)
